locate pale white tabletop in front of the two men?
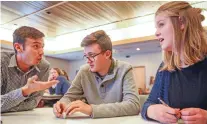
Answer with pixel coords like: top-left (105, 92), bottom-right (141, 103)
top-left (1, 108), bottom-right (157, 124)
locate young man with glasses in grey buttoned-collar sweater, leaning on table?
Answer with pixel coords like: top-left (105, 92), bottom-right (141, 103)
top-left (53, 30), bottom-right (140, 118)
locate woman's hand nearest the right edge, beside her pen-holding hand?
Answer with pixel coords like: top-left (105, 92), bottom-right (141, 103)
top-left (181, 108), bottom-right (207, 124)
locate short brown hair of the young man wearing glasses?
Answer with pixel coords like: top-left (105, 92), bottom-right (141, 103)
top-left (81, 30), bottom-right (112, 51)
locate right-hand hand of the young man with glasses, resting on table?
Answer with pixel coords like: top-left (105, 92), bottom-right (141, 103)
top-left (64, 100), bottom-right (92, 116)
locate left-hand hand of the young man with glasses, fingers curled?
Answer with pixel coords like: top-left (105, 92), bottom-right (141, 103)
top-left (53, 101), bottom-right (66, 118)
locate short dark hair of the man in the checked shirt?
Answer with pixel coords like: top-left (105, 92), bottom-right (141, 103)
top-left (13, 26), bottom-right (45, 53)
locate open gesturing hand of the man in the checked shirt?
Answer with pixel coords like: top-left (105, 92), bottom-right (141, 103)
top-left (22, 75), bottom-right (59, 96)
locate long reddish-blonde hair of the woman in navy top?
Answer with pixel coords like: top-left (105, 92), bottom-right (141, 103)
top-left (155, 1), bottom-right (207, 71)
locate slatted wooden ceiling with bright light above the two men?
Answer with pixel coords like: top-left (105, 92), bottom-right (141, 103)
top-left (1, 1), bottom-right (168, 37)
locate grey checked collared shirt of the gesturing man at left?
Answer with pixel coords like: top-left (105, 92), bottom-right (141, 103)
top-left (0, 52), bottom-right (50, 113)
